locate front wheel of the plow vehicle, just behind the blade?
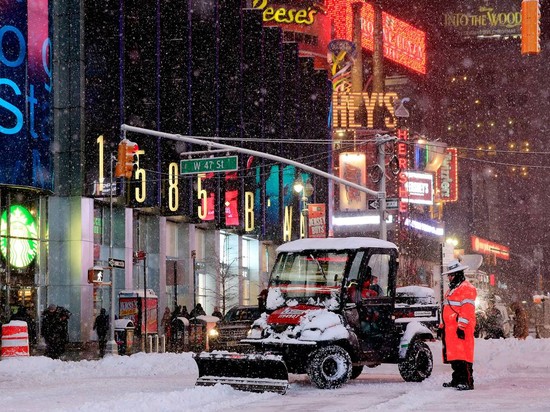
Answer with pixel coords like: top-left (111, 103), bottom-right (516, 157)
top-left (307, 345), bottom-right (352, 389)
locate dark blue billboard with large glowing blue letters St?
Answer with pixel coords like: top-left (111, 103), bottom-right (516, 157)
top-left (0, 0), bottom-right (52, 189)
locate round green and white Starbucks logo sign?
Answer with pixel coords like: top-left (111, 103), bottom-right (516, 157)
top-left (0, 205), bottom-right (38, 268)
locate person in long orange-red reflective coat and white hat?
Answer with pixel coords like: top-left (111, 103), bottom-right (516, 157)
top-left (440, 260), bottom-right (477, 390)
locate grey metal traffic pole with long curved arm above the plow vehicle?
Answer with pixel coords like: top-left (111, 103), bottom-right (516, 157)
top-left (120, 124), bottom-right (397, 240)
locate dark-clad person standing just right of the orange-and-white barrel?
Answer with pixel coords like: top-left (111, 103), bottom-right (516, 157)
top-left (42, 303), bottom-right (71, 359)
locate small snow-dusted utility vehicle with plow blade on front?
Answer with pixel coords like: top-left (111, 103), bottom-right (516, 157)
top-left (195, 237), bottom-right (434, 393)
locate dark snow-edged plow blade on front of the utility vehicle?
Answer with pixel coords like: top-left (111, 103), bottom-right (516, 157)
top-left (194, 352), bottom-right (288, 395)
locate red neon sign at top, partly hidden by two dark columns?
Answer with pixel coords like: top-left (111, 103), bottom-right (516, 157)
top-left (329, 0), bottom-right (426, 74)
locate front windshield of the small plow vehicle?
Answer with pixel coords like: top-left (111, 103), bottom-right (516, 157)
top-left (270, 251), bottom-right (350, 303)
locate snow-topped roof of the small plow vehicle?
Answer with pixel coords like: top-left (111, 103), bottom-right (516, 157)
top-left (277, 237), bottom-right (397, 252)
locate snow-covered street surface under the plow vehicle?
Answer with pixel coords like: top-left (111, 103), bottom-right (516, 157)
top-left (0, 338), bottom-right (550, 412)
